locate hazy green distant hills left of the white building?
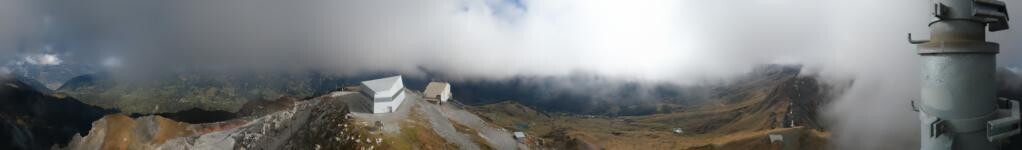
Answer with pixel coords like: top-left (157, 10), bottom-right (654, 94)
top-left (56, 72), bottom-right (357, 113)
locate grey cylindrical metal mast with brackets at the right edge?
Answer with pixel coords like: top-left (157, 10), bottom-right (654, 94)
top-left (909, 0), bottom-right (1019, 150)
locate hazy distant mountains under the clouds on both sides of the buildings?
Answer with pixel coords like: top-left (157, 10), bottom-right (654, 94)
top-left (43, 65), bottom-right (801, 115)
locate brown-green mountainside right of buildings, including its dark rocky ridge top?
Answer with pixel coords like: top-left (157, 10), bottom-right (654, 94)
top-left (470, 65), bottom-right (831, 149)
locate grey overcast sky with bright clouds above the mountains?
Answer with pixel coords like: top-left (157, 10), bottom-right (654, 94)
top-left (0, 0), bottom-right (1022, 149)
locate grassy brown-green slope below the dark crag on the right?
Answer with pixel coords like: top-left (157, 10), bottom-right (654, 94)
top-left (471, 77), bottom-right (829, 149)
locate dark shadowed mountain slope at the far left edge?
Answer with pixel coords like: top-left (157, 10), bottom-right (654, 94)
top-left (0, 77), bottom-right (113, 149)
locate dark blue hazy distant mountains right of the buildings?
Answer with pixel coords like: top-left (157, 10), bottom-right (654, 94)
top-left (452, 64), bottom-right (801, 115)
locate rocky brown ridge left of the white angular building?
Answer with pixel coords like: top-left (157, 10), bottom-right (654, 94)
top-left (61, 91), bottom-right (379, 150)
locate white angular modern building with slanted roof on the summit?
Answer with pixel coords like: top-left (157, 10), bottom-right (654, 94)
top-left (359, 76), bottom-right (405, 113)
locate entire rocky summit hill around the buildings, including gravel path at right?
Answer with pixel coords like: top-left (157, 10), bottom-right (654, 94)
top-left (66, 89), bottom-right (528, 150)
